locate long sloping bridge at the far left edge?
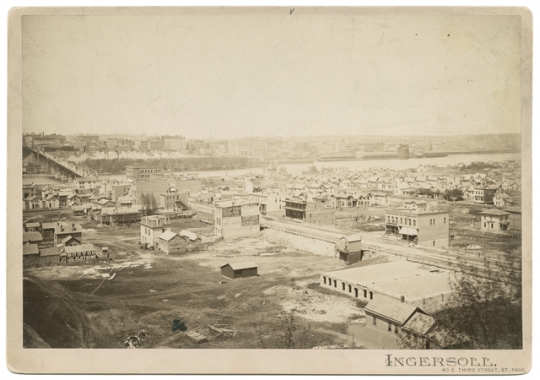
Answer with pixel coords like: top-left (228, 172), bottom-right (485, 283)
top-left (23, 147), bottom-right (98, 182)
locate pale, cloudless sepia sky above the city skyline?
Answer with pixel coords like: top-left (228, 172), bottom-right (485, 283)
top-left (22, 13), bottom-right (521, 138)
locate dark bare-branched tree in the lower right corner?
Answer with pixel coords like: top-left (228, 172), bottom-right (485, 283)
top-left (437, 251), bottom-right (523, 349)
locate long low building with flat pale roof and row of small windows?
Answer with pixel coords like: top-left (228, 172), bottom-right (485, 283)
top-left (320, 261), bottom-right (452, 313)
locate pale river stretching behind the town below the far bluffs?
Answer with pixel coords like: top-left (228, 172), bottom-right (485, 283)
top-left (23, 153), bottom-right (521, 184)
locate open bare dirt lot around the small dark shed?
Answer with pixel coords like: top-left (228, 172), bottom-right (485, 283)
top-left (24, 212), bottom-right (388, 348)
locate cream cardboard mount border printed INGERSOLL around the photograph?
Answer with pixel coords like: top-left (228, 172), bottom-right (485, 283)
top-left (6, 7), bottom-right (532, 375)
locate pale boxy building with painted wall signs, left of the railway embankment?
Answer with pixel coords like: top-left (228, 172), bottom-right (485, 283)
top-left (214, 200), bottom-right (260, 239)
